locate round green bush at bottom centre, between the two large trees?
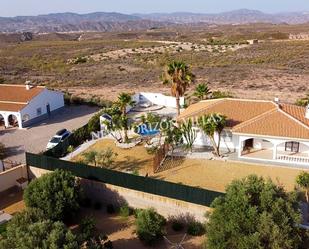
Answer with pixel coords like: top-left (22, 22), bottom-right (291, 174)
top-left (136, 208), bottom-right (166, 245)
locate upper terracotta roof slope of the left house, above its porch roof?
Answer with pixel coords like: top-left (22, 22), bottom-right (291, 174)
top-left (0, 85), bottom-right (45, 103)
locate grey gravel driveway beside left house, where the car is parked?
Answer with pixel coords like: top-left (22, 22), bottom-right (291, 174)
top-left (0, 106), bottom-right (99, 163)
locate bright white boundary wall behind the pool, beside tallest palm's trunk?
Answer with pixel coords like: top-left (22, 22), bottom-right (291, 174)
top-left (133, 92), bottom-right (185, 108)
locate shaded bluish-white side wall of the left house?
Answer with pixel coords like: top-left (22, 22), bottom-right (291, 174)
top-left (21, 89), bottom-right (64, 120)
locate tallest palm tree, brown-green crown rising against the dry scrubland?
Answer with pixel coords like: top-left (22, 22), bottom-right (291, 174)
top-left (163, 61), bottom-right (195, 115)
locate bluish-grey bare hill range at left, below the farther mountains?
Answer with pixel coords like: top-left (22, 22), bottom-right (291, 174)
top-left (0, 12), bottom-right (164, 33)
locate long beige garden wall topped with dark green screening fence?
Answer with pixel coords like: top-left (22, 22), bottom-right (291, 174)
top-left (26, 153), bottom-right (223, 220)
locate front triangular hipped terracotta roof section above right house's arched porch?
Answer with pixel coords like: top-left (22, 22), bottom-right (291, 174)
top-left (233, 110), bottom-right (309, 139)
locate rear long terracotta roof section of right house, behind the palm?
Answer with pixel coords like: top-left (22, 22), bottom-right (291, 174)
top-left (178, 99), bottom-right (277, 127)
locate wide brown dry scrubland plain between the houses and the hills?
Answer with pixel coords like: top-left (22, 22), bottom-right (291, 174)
top-left (0, 24), bottom-right (309, 102)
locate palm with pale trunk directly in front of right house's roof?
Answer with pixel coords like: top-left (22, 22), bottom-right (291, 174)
top-left (198, 113), bottom-right (227, 156)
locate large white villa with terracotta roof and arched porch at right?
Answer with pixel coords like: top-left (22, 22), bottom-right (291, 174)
top-left (178, 98), bottom-right (309, 166)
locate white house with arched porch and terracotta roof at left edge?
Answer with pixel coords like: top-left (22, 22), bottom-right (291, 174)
top-left (0, 82), bottom-right (64, 128)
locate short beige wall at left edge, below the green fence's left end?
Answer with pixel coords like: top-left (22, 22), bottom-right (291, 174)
top-left (0, 165), bottom-right (28, 192)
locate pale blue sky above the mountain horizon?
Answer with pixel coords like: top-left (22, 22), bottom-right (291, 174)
top-left (0, 0), bottom-right (309, 16)
